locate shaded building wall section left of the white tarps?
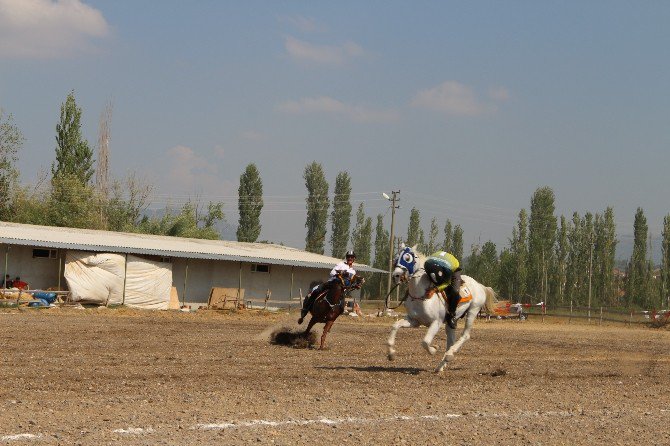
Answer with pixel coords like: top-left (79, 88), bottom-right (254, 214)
top-left (0, 245), bottom-right (65, 290)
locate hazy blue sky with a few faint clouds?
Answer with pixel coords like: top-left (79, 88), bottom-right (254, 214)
top-left (0, 0), bottom-right (670, 257)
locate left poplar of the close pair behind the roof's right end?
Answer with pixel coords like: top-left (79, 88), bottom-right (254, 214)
top-left (303, 161), bottom-right (330, 254)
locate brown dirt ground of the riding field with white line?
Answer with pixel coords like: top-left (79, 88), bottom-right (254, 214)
top-left (0, 309), bottom-right (670, 445)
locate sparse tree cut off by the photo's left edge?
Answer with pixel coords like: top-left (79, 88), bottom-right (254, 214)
top-left (0, 108), bottom-right (25, 221)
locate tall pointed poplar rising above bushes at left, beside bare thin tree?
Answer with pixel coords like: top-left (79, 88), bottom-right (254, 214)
top-left (51, 90), bottom-right (93, 185)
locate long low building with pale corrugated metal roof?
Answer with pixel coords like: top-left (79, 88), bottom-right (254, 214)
top-left (0, 222), bottom-right (386, 306)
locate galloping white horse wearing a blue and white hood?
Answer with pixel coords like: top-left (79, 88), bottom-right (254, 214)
top-left (388, 247), bottom-right (496, 372)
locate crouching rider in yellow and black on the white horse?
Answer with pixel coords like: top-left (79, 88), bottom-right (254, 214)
top-left (423, 251), bottom-right (463, 328)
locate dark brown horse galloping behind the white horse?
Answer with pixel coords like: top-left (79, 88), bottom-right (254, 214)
top-left (301, 275), bottom-right (364, 350)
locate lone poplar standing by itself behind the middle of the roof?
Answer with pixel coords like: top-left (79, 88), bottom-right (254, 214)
top-left (237, 163), bottom-right (263, 242)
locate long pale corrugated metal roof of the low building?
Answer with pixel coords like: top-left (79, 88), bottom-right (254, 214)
top-left (0, 222), bottom-right (386, 272)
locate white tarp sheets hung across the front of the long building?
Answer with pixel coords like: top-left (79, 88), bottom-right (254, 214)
top-left (65, 251), bottom-right (172, 310)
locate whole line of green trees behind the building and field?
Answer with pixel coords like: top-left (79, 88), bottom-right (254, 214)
top-left (0, 91), bottom-right (670, 308)
